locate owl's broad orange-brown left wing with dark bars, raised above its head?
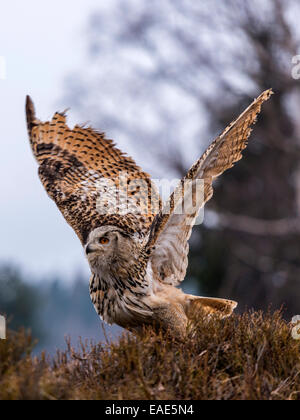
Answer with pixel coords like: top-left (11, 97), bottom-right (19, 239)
top-left (26, 96), bottom-right (160, 245)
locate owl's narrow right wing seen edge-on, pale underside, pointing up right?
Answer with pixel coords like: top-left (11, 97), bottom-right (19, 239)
top-left (147, 89), bottom-right (273, 285)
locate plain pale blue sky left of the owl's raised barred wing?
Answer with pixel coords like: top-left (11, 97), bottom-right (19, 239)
top-left (0, 0), bottom-right (105, 279)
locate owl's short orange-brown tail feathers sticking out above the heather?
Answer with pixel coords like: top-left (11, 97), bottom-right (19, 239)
top-left (186, 295), bottom-right (238, 318)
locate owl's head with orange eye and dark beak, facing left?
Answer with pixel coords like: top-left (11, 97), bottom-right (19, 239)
top-left (85, 226), bottom-right (141, 274)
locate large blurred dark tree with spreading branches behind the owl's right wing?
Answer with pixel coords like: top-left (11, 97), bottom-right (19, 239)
top-left (67, 0), bottom-right (300, 314)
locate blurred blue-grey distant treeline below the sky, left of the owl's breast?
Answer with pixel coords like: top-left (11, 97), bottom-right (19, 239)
top-left (0, 264), bottom-right (121, 354)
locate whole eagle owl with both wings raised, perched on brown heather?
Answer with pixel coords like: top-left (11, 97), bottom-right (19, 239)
top-left (26, 90), bottom-right (272, 337)
